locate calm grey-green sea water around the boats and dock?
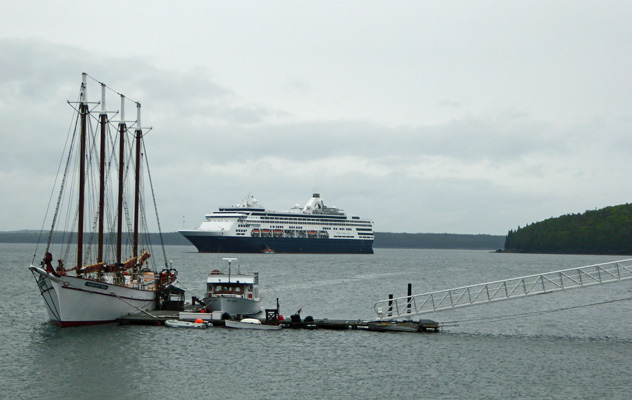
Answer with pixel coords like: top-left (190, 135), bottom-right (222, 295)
top-left (0, 244), bottom-right (632, 399)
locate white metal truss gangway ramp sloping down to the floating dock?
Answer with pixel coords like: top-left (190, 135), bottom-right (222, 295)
top-left (374, 259), bottom-right (632, 320)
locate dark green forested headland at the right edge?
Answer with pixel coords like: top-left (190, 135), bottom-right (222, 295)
top-left (505, 204), bottom-right (632, 255)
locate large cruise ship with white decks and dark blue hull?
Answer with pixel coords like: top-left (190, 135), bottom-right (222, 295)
top-left (179, 193), bottom-right (373, 254)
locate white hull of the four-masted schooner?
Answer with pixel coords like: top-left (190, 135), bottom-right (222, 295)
top-left (29, 266), bottom-right (156, 327)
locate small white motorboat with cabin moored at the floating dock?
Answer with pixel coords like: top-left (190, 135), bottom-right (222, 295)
top-left (203, 258), bottom-right (263, 317)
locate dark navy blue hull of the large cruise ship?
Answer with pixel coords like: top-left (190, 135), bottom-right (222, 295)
top-left (181, 236), bottom-right (373, 254)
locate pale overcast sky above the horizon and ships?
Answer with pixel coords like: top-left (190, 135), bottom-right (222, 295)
top-left (0, 0), bottom-right (632, 234)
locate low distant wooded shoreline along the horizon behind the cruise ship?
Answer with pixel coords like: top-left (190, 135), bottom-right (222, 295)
top-left (0, 230), bottom-right (505, 250)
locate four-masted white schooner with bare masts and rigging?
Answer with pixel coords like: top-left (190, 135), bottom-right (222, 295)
top-left (29, 73), bottom-right (178, 327)
